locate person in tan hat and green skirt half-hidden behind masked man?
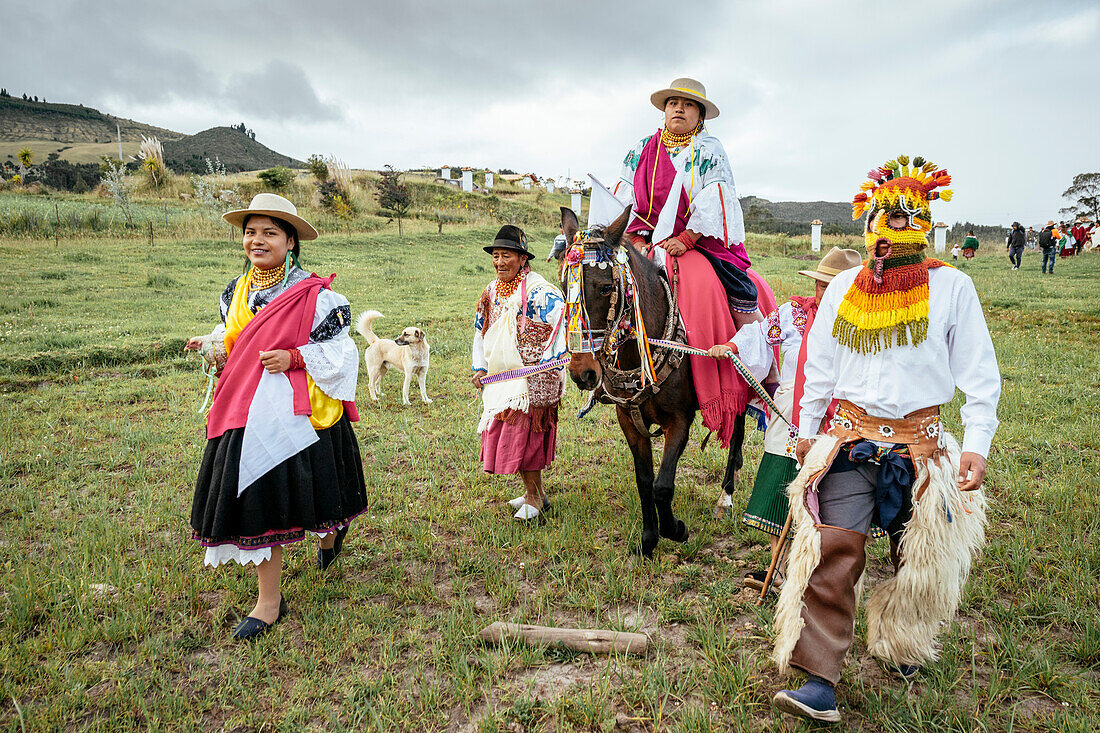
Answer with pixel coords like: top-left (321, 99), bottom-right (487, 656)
top-left (711, 247), bottom-right (860, 590)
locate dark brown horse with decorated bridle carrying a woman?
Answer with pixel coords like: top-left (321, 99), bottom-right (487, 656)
top-left (561, 207), bottom-right (745, 557)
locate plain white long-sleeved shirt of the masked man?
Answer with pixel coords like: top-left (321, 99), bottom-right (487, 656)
top-left (799, 266), bottom-right (1001, 457)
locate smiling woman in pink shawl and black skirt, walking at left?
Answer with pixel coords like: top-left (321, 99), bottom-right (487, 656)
top-left (187, 194), bottom-right (366, 639)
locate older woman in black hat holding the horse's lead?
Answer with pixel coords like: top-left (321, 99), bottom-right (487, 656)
top-left (471, 225), bottom-right (565, 522)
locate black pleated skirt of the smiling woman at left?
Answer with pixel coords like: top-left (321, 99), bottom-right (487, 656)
top-left (191, 415), bottom-right (366, 549)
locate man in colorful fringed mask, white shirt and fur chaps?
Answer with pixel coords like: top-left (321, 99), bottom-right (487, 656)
top-left (773, 155), bottom-right (1001, 722)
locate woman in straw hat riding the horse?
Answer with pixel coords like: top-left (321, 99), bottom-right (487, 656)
top-left (612, 78), bottom-right (774, 447)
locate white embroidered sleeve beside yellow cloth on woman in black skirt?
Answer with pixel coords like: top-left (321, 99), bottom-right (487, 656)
top-left (298, 289), bottom-right (359, 401)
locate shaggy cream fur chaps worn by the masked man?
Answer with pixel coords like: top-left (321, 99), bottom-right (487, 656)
top-left (772, 431), bottom-right (986, 672)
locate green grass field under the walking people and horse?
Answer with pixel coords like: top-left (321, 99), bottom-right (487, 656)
top-left (0, 222), bottom-right (1100, 732)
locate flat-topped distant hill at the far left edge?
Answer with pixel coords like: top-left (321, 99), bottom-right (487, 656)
top-left (0, 97), bottom-right (184, 143)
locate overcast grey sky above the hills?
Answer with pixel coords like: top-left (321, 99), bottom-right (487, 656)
top-left (0, 0), bottom-right (1100, 223)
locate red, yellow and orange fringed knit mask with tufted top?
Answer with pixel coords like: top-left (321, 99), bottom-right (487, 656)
top-left (833, 155), bottom-right (952, 353)
